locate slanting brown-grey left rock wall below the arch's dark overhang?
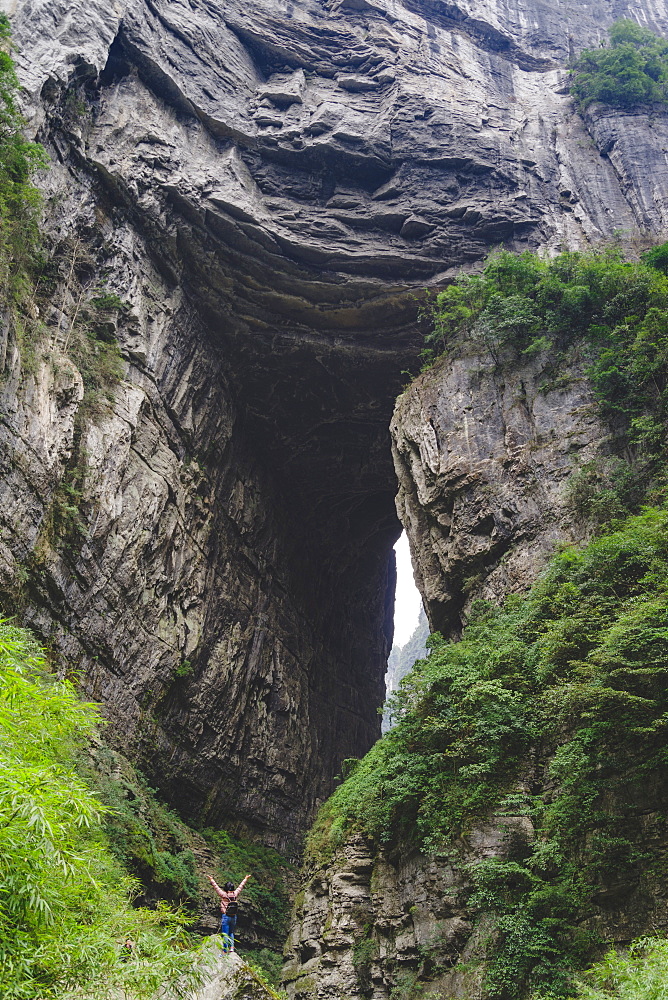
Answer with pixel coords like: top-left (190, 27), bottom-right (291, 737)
top-left (0, 203), bottom-right (394, 845)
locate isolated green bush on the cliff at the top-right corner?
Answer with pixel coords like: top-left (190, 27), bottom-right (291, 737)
top-left (571, 19), bottom-right (668, 108)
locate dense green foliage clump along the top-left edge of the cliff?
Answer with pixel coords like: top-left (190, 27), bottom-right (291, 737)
top-left (0, 14), bottom-right (47, 296)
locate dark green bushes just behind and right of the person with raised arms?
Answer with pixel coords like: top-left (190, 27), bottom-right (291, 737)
top-left (203, 829), bottom-right (290, 943)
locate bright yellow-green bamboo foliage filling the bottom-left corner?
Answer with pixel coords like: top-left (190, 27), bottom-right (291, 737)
top-left (0, 622), bottom-right (201, 1000)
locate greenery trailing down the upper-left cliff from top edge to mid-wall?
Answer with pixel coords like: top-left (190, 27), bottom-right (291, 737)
top-left (0, 14), bottom-right (127, 576)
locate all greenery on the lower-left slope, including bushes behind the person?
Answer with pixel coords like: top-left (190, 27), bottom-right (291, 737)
top-left (0, 622), bottom-right (288, 1000)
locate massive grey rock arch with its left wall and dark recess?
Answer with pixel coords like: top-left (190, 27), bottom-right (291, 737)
top-left (0, 0), bottom-right (668, 845)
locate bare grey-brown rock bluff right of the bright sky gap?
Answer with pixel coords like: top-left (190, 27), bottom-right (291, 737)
top-left (392, 347), bottom-right (612, 635)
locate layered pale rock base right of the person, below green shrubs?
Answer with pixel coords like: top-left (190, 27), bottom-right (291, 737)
top-left (284, 816), bottom-right (532, 1000)
